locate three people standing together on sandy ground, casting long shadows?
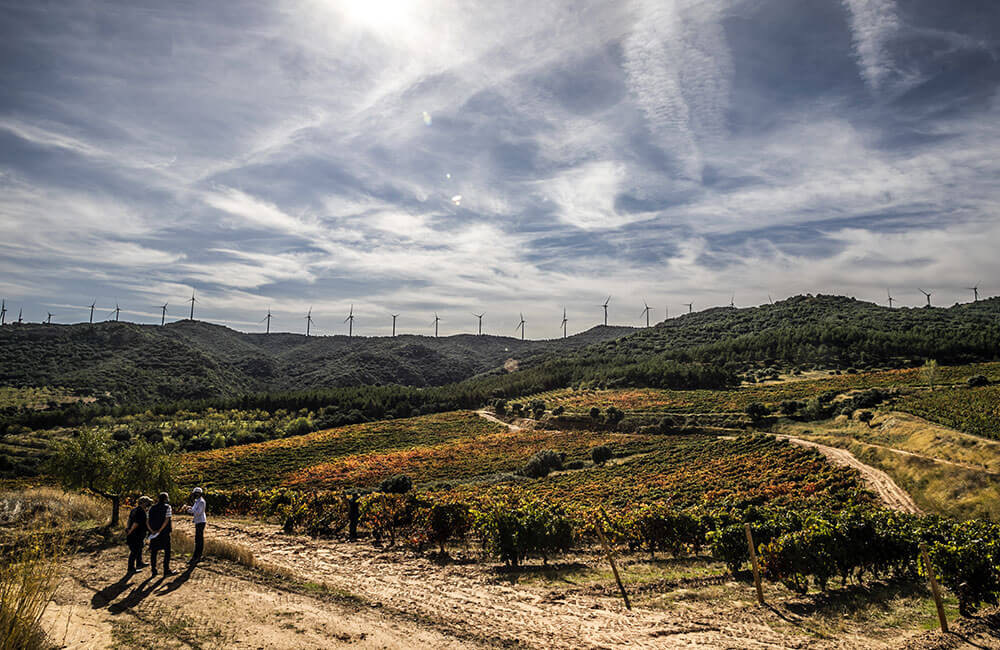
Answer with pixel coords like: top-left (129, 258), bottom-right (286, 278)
top-left (125, 488), bottom-right (208, 576)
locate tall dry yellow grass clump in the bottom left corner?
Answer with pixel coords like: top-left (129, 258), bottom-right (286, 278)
top-left (0, 536), bottom-right (62, 650)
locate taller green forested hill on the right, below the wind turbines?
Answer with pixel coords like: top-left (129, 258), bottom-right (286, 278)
top-left (578, 295), bottom-right (1000, 371)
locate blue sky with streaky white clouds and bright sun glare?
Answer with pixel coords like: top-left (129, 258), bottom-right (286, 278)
top-left (0, 0), bottom-right (1000, 338)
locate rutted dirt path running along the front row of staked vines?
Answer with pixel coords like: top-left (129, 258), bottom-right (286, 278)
top-left (201, 519), bottom-right (876, 648)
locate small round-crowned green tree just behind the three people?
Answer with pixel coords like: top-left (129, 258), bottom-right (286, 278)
top-left (49, 429), bottom-right (176, 527)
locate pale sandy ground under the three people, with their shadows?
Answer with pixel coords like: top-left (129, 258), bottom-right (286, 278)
top-left (43, 546), bottom-right (470, 649)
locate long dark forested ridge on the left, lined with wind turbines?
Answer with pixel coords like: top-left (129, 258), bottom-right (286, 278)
top-left (0, 321), bottom-right (634, 402)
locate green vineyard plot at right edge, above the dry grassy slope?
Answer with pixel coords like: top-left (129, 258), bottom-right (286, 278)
top-left (897, 386), bottom-right (1000, 440)
